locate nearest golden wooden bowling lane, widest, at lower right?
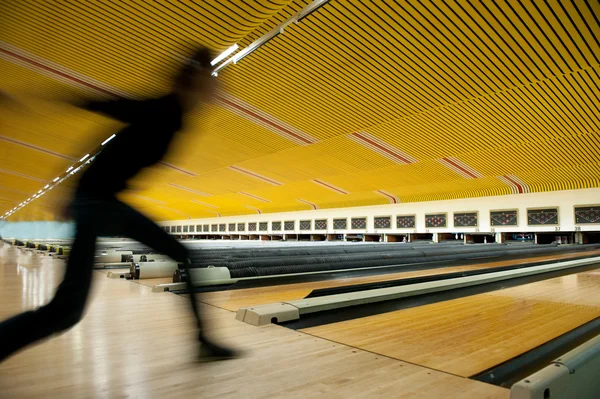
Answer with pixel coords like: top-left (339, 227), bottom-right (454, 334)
top-left (301, 264), bottom-right (600, 377)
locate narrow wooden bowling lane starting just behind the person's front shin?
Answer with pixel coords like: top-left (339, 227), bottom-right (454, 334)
top-left (202, 251), bottom-right (600, 312)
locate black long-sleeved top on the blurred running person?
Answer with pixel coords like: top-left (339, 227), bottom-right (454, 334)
top-left (77, 95), bottom-right (183, 197)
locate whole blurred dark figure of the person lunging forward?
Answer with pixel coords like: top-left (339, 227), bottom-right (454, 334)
top-left (0, 48), bottom-right (238, 362)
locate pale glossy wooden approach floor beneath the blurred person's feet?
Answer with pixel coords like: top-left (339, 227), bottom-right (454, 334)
top-left (0, 246), bottom-right (509, 399)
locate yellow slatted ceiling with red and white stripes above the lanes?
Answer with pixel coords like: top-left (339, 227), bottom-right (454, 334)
top-left (0, 0), bottom-right (600, 219)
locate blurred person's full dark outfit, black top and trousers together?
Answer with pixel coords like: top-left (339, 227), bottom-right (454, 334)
top-left (0, 96), bottom-right (202, 362)
